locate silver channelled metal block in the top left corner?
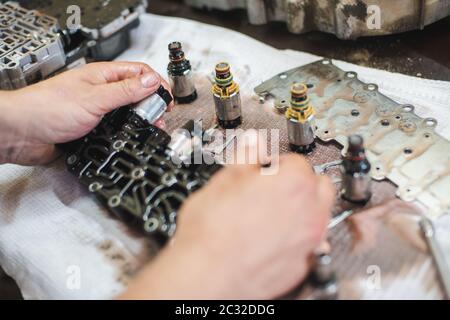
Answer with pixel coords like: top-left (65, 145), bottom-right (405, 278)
top-left (0, 1), bottom-right (66, 90)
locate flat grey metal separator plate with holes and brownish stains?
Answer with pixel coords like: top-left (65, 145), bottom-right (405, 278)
top-left (255, 59), bottom-right (450, 218)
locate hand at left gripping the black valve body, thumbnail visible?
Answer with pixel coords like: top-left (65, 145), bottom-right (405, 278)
top-left (0, 62), bottom-right (171, 165)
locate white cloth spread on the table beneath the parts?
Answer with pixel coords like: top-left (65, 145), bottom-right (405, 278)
top-left (0, 15), bottom-right (450, 299)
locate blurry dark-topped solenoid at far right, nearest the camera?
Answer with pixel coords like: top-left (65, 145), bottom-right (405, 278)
top-left (341, 135), bottom-right (372, 204)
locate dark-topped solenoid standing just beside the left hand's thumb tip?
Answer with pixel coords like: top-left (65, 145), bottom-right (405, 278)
top-left (167, 42), bottom-right (197, 104)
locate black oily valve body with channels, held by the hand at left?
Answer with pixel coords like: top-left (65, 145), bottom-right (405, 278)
top-left (61, 87), bottom-right (221, 242)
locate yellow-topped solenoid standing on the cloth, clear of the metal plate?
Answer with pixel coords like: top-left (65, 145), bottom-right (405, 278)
top-left (212, 62), bottom-right (242, 129)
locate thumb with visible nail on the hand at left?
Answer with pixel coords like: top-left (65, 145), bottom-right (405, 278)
top-left (96, 71), bottom-right (161, 114)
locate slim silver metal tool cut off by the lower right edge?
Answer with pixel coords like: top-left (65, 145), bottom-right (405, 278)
top-left (419, 218), bottom-right (450, 299)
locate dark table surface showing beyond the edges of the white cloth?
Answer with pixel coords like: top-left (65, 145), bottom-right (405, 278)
top-left (0, 0), bottom-right (450, 299)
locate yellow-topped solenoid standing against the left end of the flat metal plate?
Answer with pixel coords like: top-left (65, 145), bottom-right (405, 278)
top-left (286, 83), bottom-right (316, 154)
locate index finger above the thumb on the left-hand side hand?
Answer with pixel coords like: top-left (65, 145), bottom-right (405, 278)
top-left (80, 62), bottom-right (154, 84)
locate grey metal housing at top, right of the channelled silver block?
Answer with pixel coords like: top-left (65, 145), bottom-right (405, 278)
top-left (19, 0), bottom-right (148, 63)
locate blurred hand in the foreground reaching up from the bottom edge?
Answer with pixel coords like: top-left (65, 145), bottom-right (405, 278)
top-left (122, 155), bottom-right (334, 299)
